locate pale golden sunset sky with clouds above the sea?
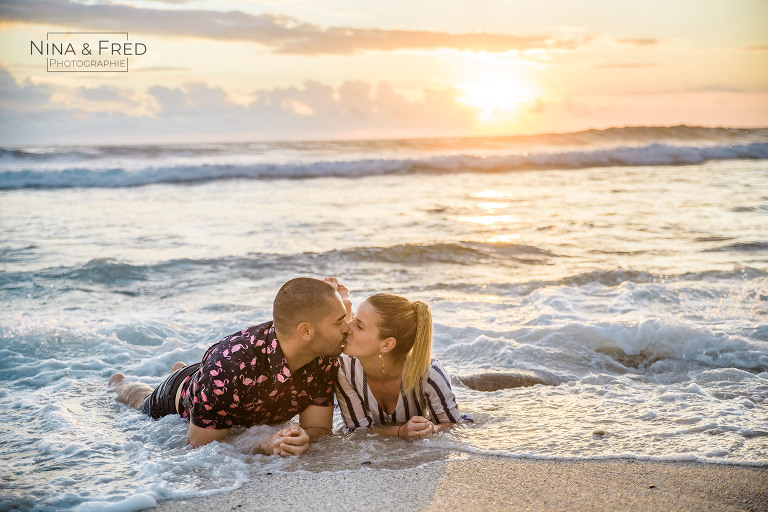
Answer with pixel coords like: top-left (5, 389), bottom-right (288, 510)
top-left (0, 0), bottom-right (768, 146)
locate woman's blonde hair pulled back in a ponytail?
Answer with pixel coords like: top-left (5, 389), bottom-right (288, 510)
top-left (367, 293), bottom-right (432, 391)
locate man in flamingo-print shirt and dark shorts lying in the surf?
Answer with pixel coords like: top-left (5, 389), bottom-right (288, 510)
top-left (109, 277), bottom-right (350, 456)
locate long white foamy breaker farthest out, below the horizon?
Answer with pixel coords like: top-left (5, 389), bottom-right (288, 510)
top-left (0, 142), bottom-right (768, 189)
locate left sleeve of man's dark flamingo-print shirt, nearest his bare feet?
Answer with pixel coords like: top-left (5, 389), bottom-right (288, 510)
top-left (189, 334), bottom-right (242, 428)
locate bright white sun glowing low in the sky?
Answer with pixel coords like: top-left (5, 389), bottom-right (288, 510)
top-left (458, 78), bottom-right (536, 121)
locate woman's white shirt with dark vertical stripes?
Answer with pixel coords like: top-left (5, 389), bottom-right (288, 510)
top-left (335, 354), bottom-right (463, 429)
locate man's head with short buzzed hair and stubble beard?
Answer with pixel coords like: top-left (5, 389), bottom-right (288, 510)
top-left (272, 277), bottom-right (349, 356)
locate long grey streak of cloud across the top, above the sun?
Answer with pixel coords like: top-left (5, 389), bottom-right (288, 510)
top-left (0, 0), bottom-right (590, 55)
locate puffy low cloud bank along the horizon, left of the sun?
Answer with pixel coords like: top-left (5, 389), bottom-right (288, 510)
top-left (0, 68), bottom-right (478, 144)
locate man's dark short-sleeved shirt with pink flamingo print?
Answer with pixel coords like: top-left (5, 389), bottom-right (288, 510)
top-left (180, 322), bottom-right (339, 428)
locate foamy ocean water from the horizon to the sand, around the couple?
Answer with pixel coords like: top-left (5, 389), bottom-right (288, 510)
top-left (0, 126), bottom-right (768, 512)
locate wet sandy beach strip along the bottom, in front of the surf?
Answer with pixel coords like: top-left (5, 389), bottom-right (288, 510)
top-left (153, 455), bottom-right (768, 512)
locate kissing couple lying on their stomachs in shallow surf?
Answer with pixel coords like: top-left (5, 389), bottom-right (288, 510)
top-left (109, 277), bottom-right (467, 456)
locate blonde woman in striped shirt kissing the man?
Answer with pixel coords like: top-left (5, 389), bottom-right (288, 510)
top-left (336, 285), bottom-right (470, 439)
